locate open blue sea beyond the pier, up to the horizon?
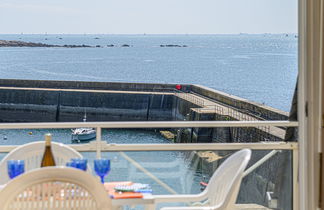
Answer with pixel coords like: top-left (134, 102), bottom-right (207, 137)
top-left (0, 34), bottom-right (297, 111)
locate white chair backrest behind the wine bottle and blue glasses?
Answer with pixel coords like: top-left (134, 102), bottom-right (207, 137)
top-left (0, 141), bottom-right (87, 184)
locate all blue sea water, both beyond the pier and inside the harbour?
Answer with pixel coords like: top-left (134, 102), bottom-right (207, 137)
top-left (0, 34), bottom-right (298, 208)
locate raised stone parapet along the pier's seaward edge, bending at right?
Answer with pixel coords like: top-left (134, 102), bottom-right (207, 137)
top-left (0, 79), bottom-right (288, 120)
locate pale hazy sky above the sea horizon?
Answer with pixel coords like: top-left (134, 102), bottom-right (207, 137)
top-left (0, 0), bottom-right (297, 34)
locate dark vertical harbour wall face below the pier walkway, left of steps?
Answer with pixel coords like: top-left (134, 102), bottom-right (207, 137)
top-left (0, 89), bottom-right (174, 122)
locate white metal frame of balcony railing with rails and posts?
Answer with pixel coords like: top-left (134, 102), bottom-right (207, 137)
top-left (0, 121), bottom-right (299, 209)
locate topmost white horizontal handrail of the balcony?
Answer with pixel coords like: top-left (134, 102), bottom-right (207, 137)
top-left (0, 121), bottom-right (298, 129)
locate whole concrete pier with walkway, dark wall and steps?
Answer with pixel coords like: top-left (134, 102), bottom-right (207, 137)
top-left (0, 79), bottom-right (288, 142)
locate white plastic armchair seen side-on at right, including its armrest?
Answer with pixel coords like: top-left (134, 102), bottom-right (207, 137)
top-left (154, 149), bottom-right (251, 210)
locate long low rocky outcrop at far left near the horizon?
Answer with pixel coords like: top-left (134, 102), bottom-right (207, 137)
top-left (0, 40), bottom-right (92, 48)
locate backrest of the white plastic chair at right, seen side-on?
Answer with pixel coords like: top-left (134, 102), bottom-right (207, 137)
top-left (202, 149), bottom-right (251, 209)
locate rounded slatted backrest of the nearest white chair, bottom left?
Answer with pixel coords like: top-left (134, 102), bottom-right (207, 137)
top-left (0, 167), bottom-right (112, 210)
